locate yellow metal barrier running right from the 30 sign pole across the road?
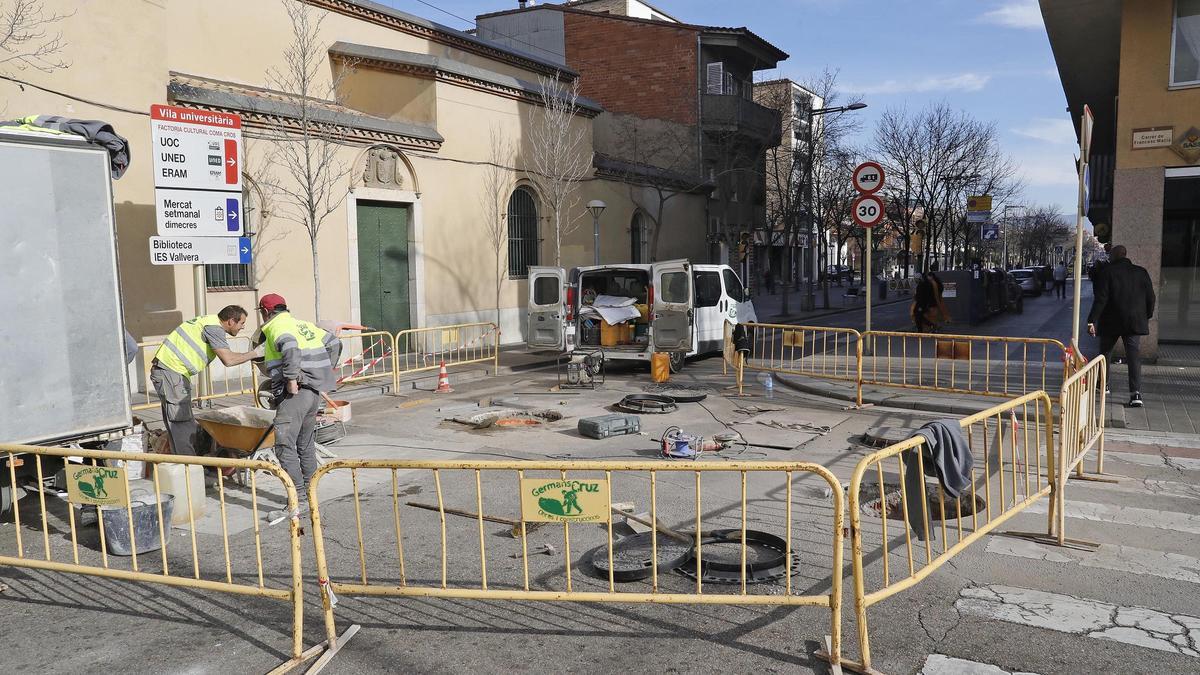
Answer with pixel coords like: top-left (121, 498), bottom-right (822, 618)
top-left (860, 330), bottom-right (1069, 398)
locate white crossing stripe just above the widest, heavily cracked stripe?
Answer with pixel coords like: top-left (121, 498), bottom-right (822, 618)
top-left (988, 537), bottom-right (1200, 584)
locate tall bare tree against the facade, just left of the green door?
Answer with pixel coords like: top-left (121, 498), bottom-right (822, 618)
top-left (266, 0), bottom-right (353, 319)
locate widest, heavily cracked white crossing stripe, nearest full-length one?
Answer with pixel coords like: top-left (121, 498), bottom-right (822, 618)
top-left (954, 586), bottom-right (1200, 657)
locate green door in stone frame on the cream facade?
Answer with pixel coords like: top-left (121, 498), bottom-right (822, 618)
top-left (358, 202), bottom-right (412, 333)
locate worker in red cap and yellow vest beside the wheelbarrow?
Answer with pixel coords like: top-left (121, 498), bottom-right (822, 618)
top-left (258, 293), bottom-right (335, 511)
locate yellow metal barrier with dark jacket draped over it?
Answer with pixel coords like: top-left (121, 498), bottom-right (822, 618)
top-left (850, 392), bottom-right (1058, 671)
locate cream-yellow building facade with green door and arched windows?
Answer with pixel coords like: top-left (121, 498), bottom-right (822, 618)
top-left (0, 0), bottom-right (706, 344)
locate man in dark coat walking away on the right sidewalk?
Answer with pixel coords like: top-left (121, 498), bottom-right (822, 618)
top-left (1087, 246), bottom-right (1156, 407)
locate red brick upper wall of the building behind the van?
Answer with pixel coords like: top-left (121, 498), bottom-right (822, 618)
top-left (563, 12), bottom-right (698, 124)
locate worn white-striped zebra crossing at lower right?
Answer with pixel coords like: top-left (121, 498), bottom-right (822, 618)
top-left (955, 446), bottom-right (1200, 671)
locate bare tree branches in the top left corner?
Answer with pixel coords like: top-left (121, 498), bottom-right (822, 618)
top-left (0, 0), bottom-right (71, 77)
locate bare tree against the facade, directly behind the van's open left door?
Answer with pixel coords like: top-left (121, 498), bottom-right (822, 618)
top-left (527, 72), bottom-right (592, 267)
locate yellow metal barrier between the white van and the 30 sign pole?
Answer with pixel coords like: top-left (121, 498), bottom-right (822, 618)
top-left (738, 323), bottom-right (863, 405)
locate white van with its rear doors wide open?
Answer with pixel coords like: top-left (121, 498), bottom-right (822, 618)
top-left (526, 261), bottom-right (757, 372)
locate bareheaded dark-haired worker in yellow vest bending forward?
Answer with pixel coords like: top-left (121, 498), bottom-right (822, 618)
top-left (150, 305), bottom-right (259, 455)
